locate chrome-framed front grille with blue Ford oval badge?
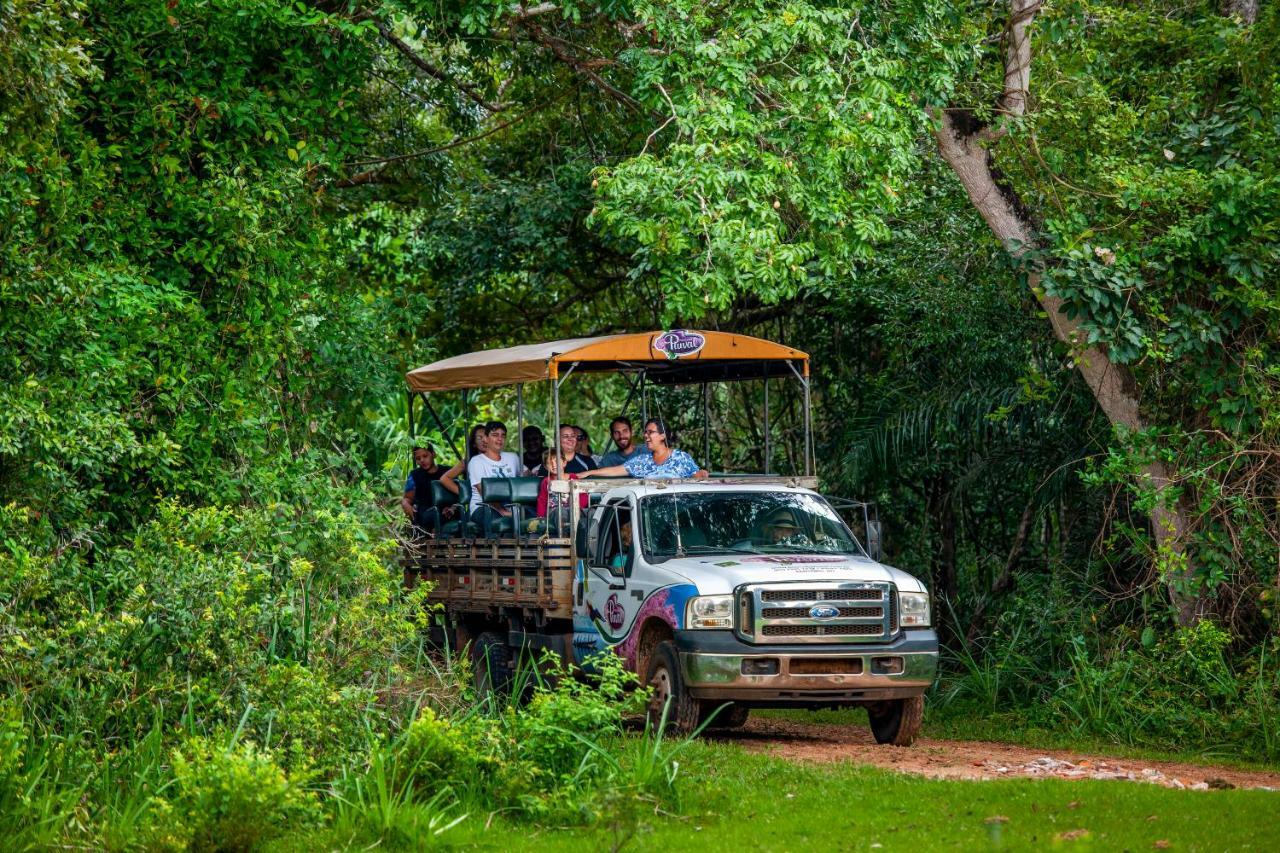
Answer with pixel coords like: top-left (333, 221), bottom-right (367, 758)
top-left (737, 581), bottom-right (897, 643)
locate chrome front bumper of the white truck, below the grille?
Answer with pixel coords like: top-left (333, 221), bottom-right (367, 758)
top-left (676, 629), bottom-right (938, 707)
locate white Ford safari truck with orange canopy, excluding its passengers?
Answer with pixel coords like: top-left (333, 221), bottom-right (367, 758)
top-left (404, 329), bottom-right (938, 745)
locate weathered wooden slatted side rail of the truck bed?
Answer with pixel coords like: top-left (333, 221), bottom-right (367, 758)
top-left (402, 538), bottom-right (573, 619)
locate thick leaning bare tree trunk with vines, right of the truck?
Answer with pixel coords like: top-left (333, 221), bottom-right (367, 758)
top-left (934, 108), bottom-right (1204, 625)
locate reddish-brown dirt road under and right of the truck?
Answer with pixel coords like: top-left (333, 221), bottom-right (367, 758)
top-left (713, 717), bottom-right (1280, 792)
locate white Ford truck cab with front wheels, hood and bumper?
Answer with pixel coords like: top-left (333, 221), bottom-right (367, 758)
top-left (573, 478), bottom-right (938, 743)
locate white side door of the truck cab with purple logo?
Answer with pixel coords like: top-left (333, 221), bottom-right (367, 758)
top-left (584, 498), bottom-right (653, 644)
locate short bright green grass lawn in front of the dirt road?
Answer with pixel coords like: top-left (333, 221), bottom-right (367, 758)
top-left (363, 743), bottom-right (1280, 852)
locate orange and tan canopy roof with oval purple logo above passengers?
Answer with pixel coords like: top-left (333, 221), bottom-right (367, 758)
top-left (406, 329), bottom-right (809, 391)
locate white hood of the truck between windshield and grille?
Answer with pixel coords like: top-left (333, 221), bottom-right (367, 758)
top-left (654, 553), bottom-right (924, 596)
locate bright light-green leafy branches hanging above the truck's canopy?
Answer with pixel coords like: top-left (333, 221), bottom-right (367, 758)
top-left (594, 3), bottom-right (954, 316)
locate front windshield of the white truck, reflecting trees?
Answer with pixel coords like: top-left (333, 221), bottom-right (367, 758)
top-left (640, 491), bottom-right (865, 560)
